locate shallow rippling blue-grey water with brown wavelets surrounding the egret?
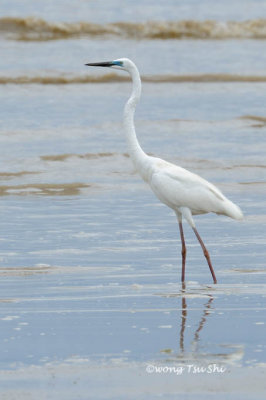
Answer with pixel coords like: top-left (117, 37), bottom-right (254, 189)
top-left (0, 0), bottom-right (266, 400)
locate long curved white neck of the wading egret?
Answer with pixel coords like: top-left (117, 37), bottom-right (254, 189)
top-left (124, 63), bottom-right (149, 180)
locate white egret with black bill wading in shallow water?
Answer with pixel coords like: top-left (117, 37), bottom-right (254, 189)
top-left (86, 58), bottom-right (243, 283)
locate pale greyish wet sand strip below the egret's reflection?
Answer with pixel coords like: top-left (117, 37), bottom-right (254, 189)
top-left (0, 359), bottom-right (266, 400)
